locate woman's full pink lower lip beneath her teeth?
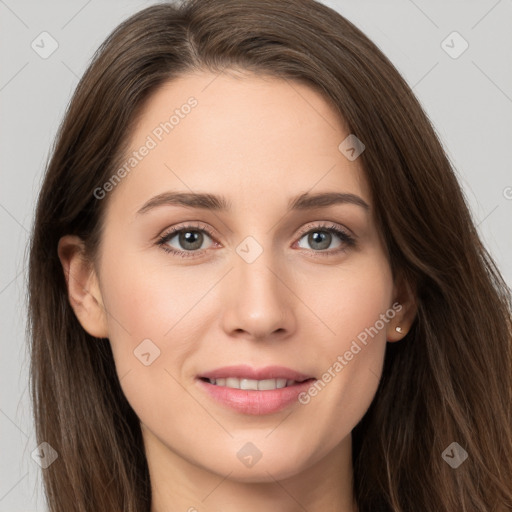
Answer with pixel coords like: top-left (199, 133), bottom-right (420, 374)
top-left (198, 379), bottom-right (314, 416)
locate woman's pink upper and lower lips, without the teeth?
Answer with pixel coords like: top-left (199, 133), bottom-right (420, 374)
top-left (197, 365), bottom-right (314, 415)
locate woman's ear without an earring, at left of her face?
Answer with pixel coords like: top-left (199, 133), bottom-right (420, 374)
top-left (58, 235), bottom-right (108, 338)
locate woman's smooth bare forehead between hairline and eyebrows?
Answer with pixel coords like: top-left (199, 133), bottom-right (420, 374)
top-left (110, 72), bottom-right (370, 212)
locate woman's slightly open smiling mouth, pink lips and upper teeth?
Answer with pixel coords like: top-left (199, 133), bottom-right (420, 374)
top-left (196, 365), bottom-right (316, 415)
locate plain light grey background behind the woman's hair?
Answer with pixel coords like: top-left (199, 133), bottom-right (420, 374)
top-left (0, 0), bottom-right (512, 512)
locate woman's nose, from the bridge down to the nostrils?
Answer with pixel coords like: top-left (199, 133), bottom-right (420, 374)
top-left (222, 251), bottom-right (298, 341)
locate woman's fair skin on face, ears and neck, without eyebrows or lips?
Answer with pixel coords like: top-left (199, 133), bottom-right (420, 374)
top-left (59, 72), bottom-right (415, 512)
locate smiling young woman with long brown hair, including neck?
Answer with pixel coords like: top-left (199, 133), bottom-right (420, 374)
top-left (29, 0), bottom-right (512, 512)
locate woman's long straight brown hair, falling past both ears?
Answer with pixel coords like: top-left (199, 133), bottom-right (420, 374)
top-left (29, 0), bottom-right (512, 512)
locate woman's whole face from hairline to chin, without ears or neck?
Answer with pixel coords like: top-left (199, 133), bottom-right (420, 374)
top-left (74, 72), bottom-right (406, 482)
